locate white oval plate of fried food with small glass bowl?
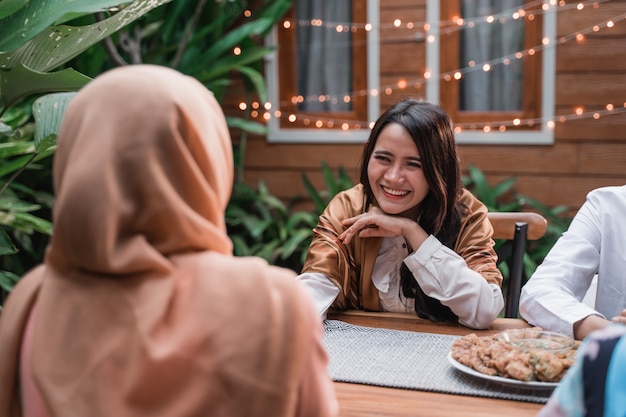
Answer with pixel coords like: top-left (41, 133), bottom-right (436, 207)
top-left (448, 327), bottom-right (580, 388)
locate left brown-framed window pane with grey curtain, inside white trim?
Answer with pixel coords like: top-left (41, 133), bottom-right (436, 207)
top-left (275, 0), bottom-right (368, 130)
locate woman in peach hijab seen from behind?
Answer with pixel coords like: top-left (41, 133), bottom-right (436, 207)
top-left (0, 65), bottom-right (337, 417)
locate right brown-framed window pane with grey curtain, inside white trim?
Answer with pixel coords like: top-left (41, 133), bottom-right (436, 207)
top-left (439, 0), bottom-right (544, 130)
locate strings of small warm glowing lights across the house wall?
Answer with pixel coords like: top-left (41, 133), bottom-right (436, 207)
top-left (234, 0), bottom-right (626, 133)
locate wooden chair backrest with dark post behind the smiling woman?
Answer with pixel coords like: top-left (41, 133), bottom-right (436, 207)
top-left (487, 211), bottom-right (548, 318)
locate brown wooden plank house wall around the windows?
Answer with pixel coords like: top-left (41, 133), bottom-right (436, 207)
top-left (224, 0), bottom-right (626, 213)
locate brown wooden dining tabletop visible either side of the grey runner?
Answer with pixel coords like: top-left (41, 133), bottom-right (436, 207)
top-left (328, 311), bottom-right (543, 417)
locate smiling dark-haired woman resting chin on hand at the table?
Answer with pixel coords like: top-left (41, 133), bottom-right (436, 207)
top-left (298, 99), bottom-right (504, 328)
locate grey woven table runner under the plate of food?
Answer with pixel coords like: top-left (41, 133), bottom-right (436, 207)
top-left (324, 320), bottom-right (553, 403)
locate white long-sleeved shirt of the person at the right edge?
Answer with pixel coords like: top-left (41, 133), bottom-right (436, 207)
top-left (520, 185), bottom-right (626, 336)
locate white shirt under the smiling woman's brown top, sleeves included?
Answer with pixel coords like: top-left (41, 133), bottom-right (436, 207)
top-left (298, 235), bottom-right (504, 329)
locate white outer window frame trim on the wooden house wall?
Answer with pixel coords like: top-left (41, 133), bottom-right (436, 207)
top-left (265, 0), bottom-right (556, 145)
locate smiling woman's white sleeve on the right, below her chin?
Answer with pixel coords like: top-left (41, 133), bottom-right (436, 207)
top-left (404, 235), bottom-right (504, 329)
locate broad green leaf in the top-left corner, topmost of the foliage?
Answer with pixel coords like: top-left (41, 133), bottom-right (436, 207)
top-left (0, 0), bottom-right (131, 53)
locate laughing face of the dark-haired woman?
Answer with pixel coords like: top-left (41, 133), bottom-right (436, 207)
top-left (367, 123), bottom-right (430, 219)
